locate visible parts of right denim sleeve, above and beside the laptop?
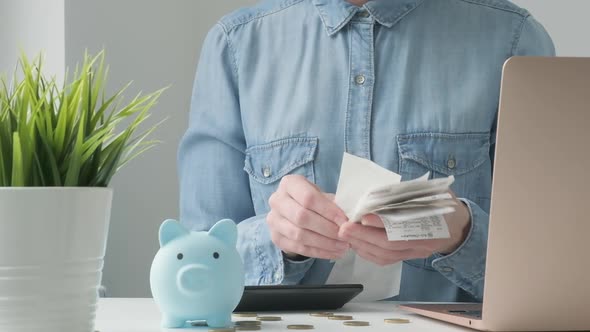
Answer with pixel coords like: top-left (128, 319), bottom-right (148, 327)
top-left (432, 16), bottom-right (555, 301)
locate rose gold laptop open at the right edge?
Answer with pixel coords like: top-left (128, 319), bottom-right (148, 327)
top-left (402, 57), bottom-right (590, 331)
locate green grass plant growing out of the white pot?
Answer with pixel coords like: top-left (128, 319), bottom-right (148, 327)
top-left (0, 52), bottom-right (164, 187)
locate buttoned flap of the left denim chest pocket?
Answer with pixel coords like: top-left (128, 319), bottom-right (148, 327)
top-left (244, 137), bottom-right (318, 184)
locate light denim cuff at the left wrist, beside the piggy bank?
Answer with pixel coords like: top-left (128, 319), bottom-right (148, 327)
top-left (236, 214), bottom-right (314, 286)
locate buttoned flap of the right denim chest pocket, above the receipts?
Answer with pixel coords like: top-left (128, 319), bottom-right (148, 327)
top-left (397, 133), bottom-right (490, 175)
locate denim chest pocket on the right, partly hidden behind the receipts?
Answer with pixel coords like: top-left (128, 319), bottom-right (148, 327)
top-left (397, 133), bottom-right (492, 214)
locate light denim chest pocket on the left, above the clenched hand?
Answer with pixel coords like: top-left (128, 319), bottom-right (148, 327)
top-left (244, 137), bottom-right (318, 214)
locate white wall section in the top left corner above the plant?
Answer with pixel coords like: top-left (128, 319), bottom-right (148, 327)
top-left (0, 0), bottom-right (65, 80)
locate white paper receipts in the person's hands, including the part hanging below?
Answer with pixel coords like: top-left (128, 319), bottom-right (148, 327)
top-left (326, 153), bottom-right (455, 302)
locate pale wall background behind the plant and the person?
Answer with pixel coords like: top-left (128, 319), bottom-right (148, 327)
top-left (0, 0), bottom-right (590, 297)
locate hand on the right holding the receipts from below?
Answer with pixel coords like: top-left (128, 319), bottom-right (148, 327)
top-left (339, 192), bottom-right (471, 266)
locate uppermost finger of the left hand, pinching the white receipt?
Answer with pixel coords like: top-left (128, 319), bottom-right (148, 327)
top-left (279, 175), bottom-right (348, 225)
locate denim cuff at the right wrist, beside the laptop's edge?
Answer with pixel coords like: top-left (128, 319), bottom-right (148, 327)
top-left (432, 199), bottom-right (489, 301)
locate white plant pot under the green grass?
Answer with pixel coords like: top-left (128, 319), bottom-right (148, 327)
top-left (0, 187), bottom-right (112, 332)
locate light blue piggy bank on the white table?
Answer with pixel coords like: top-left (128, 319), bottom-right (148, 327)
top-left (150, 219), bottom-right (244, 328)
